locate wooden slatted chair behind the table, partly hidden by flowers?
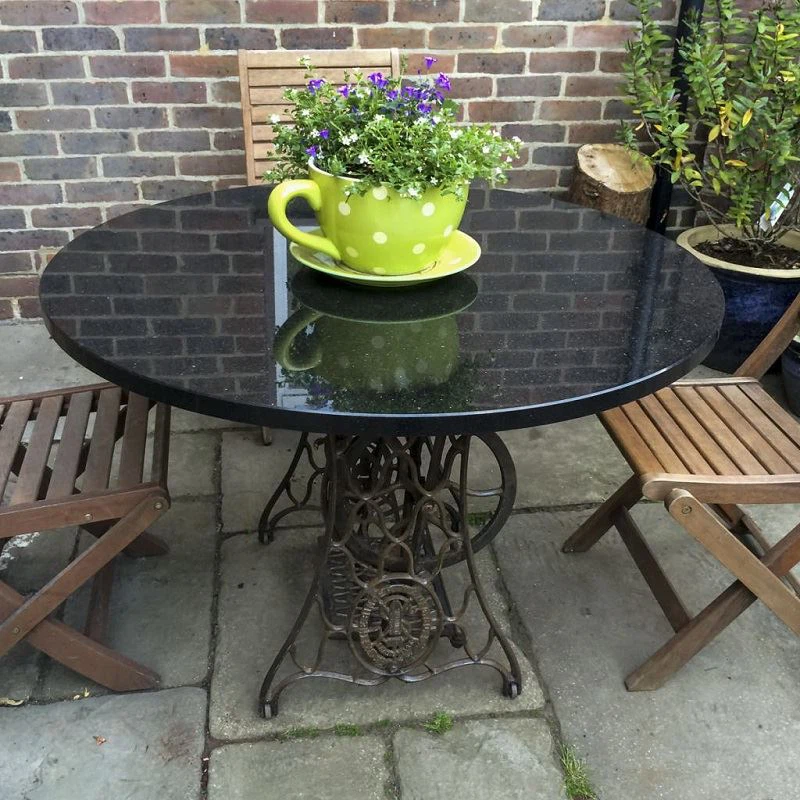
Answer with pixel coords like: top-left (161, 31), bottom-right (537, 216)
top-left (239, 47), bottom-right (400, 444)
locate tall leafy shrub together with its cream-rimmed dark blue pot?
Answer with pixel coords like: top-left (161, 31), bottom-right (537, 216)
top-left (623, 0), bottom-right (800, 371)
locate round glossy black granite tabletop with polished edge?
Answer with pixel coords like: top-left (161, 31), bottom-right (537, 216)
top-left (40, 186), bottom-right (723, 435)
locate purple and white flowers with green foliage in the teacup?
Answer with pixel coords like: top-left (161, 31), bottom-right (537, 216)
top-left (264, 58), bottom-right (520, 197)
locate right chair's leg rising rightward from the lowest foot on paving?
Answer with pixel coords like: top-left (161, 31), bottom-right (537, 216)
top-left (625, 506), bottom-right (800, 692)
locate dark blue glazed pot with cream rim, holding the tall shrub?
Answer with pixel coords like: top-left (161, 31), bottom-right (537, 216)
top-left (678, 225), bottom-right (800, 372)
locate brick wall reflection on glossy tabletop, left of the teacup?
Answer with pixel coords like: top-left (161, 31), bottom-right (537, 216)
top-left (49, 195), bottom-right (275, 398)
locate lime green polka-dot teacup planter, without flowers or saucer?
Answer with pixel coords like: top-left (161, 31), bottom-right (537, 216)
top-left (267, 163), bottom-right (467, 275)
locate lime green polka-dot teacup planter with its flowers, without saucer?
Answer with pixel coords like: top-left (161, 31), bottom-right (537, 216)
top-left (265, 57), bottom-right (519, 275)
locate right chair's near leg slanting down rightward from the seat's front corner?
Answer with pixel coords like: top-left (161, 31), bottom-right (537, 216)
top-left (665, 489), bottom-right (800, 636)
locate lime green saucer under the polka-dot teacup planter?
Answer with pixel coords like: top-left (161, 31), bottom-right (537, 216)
top-left (289, 228), bottom-right (481, 286)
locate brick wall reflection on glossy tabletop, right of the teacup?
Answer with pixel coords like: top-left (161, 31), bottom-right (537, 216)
top-left (458, 195), bottom-right (679, 405)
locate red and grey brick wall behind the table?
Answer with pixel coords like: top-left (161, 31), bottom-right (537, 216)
top-left (0, 0), bottom-right (681, 320)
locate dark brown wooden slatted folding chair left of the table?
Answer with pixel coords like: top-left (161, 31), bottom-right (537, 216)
top-left (0, 383), bottom-right (170, 691)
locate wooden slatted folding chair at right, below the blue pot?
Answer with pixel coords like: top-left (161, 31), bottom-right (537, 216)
top-left (563, 294), bottom-right (800, 691)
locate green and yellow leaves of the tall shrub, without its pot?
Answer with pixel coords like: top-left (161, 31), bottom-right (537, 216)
top-left (623, 0), bottom-right (800, 251)
